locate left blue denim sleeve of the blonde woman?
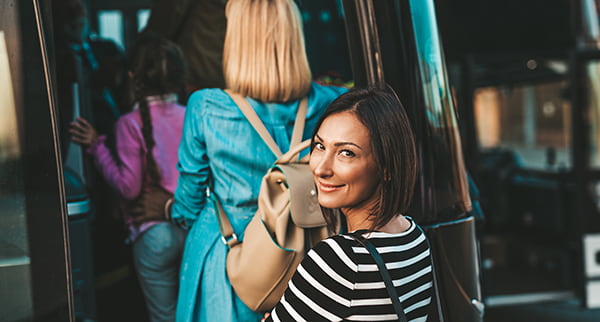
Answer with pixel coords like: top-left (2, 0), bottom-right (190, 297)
top-left (170, 92), bottom-right (210, 227)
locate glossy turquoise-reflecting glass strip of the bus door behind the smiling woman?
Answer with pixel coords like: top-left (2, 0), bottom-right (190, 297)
top-left (410, 0), bottom-right (471, 215)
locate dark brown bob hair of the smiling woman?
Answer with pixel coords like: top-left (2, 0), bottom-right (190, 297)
top-left (312, 86), bottom-right (417, 230)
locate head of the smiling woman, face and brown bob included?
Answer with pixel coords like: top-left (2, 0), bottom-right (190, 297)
top-left (311, 85), bottom-right (417, 230)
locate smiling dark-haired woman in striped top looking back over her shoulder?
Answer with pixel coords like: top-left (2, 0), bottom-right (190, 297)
top-left (267, 88), bottom-right (433, 321)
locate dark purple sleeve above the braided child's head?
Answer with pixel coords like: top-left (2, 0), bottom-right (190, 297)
top-left (144, 0), bottom-right (191, 40)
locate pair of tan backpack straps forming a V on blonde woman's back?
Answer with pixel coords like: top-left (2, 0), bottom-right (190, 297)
top-left (225, 89), bottom-right (308, 158)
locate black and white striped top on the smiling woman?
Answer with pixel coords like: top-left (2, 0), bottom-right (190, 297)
top-left (267, 220), bottom-right (433, 322)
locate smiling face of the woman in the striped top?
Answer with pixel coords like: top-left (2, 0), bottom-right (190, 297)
top-left (310, 112), bottom-right (379, 215)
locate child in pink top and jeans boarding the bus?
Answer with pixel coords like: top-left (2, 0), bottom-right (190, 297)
top-left (70, 34), bottom-right (185, 321)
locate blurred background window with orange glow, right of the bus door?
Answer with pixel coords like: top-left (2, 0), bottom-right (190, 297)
top-left (473, 81), bottom-right (571, 170)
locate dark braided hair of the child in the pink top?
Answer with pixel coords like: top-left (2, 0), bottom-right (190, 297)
top-left (129, 33), bottom-right (186, 183)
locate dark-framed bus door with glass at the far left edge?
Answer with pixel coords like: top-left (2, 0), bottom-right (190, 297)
top-left (0, 0), bottom-right (74, 321)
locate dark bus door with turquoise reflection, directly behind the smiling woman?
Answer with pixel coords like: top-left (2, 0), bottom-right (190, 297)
top-left (342, 0), bottom-right (484, 321)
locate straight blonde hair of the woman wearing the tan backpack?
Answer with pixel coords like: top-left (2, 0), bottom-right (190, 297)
top-left (223, 0), bottom-right (312, 102)
